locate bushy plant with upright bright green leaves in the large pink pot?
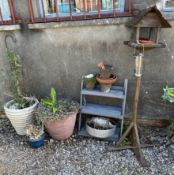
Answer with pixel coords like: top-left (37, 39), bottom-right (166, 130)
top-left (35, 87), bottom-right (79, 122)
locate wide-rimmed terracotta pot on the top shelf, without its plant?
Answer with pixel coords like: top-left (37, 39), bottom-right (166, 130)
top-left (96, 74), bottom-right (117, 92)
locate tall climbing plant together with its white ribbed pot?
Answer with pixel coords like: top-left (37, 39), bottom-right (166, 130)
top-left (4, 47), bottom-right (38, 135)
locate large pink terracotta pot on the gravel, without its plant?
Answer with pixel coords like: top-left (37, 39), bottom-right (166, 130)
top-left (45, 112), bottom-right (77, 140)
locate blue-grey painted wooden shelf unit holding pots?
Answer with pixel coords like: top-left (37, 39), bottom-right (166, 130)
top-left (78, 78), bottom-right (128, 141)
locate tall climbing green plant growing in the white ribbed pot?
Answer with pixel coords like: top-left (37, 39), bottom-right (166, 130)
top-left (7, 50), bottom-right (29, 109)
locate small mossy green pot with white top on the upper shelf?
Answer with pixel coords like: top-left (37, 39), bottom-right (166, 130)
top-left (83, 74), bottom-right (96, 90)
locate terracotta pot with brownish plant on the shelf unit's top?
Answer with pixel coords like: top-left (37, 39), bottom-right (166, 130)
top-left (96, 63), bottom-right (117, 92)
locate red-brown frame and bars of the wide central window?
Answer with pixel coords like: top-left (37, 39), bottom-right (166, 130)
top-left (28, 0), bottom-right (132, 23)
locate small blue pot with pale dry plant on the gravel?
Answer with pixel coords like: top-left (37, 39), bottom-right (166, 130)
top-left (26, 124), bottom-right (45, 148)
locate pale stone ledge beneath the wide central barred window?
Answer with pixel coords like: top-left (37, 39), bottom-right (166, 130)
top-left (28, 17), bottom-right (131, 30)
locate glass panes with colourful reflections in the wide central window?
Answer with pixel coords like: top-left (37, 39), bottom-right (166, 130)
top-left (39, 0), bottom-right (125, 17)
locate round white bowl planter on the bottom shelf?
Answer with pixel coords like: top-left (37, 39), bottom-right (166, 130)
top-left (86, 117), bottom-right (116, 138)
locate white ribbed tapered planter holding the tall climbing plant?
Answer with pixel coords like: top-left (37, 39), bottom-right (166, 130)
top-left (4, 97), bottom-right (39, 135)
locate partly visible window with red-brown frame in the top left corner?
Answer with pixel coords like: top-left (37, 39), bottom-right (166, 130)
top-left (0, 0), bottom-right (18, 25)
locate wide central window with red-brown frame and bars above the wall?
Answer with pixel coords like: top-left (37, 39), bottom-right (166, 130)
top-left (29, 0), bottom-right (131, 22)
